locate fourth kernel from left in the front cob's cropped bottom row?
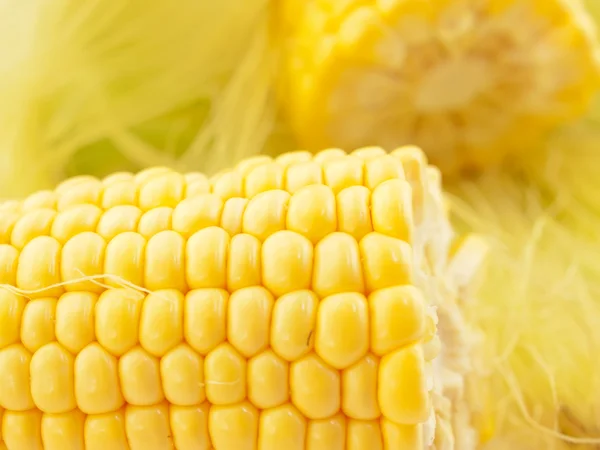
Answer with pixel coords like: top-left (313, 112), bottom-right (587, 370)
top-left (125, 403), bottom-right (174, 450)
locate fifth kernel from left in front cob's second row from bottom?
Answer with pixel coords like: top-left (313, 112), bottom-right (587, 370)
top-left (160, 344), bottom-right (206, 406)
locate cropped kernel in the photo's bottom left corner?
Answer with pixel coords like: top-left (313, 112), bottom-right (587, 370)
top-left (2, 409), bottom-right (44, 450)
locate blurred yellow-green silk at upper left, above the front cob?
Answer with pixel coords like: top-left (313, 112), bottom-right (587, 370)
top-left (0, 0), bottom-right (274, 198)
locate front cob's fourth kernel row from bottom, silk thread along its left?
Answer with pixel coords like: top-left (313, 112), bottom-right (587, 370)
top-left (0, 227), bottom-right (414, 298)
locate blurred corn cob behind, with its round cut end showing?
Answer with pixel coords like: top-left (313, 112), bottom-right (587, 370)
top-left (282, 0), bottom-right (600, 174)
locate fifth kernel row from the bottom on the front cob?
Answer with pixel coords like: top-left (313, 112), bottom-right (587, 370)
top-left (0, 179), bottom-right (413, 246)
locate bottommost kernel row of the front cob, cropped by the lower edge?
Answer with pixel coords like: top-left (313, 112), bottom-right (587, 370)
top-left (0, 402), bottom-right (423, 450)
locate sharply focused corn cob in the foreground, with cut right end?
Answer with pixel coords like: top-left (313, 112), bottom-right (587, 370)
top-left (0, 147), bottom-right (480, 450)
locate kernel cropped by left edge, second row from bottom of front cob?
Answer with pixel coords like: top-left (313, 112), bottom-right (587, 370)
top-left (0, 344), bottom-right (35, 411)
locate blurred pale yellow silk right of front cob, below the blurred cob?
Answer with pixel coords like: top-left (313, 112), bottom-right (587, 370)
top-left (450, 120), bottom-right (600, 450)
